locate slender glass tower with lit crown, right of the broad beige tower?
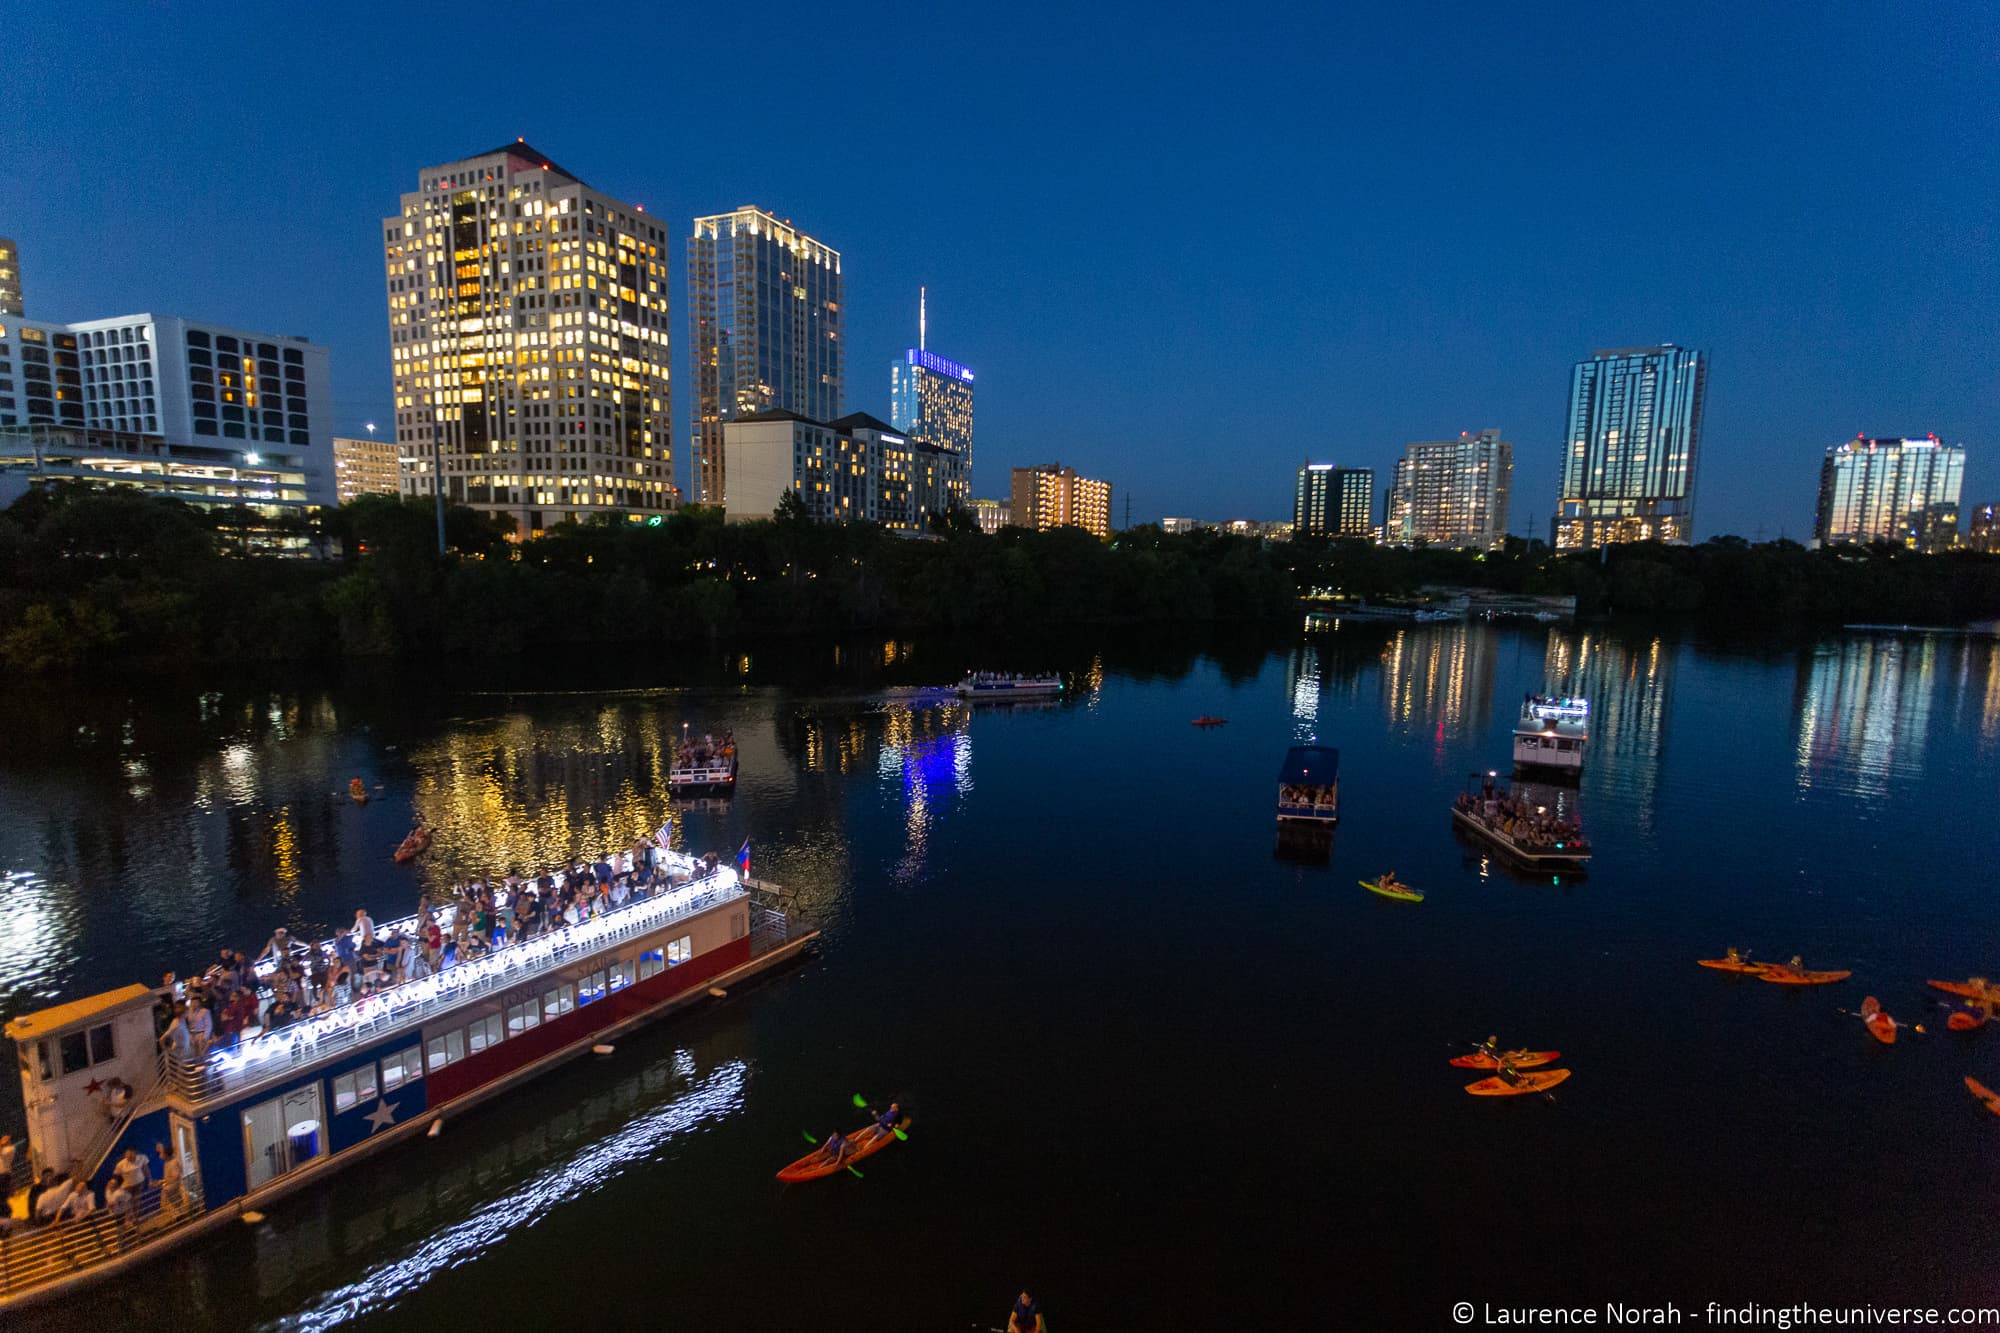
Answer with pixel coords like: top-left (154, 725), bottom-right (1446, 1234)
top-left (688, 206), bottom-right (848, 516)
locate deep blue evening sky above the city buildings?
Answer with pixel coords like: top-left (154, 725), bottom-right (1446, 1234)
top-left (0, 0), bottom-right (2000, 536)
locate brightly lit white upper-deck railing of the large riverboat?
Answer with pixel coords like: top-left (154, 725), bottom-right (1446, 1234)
top-left (160, 867), bottom-right (746, 1103)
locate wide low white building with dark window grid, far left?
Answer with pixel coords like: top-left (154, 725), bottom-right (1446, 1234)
top-left (0, 314), bottom-right (334, 514)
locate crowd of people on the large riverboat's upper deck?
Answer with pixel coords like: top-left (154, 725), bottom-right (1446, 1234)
top-left (156, 835), bottom-right (720, 1064)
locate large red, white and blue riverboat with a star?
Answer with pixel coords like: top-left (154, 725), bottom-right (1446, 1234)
top-left (0, 849), bottom-right (818, 1313)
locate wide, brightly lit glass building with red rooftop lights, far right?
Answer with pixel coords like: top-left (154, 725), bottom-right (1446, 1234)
top-left (1812, 434), bottom-right (1966, 550)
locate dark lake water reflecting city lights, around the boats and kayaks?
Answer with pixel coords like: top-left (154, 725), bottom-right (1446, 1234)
top-left (0, 622), bottom-right (2000, 1333)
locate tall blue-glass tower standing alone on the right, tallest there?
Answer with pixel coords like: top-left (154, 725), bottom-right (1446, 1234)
top-left (1552, 344), bottom-right (1708, 550)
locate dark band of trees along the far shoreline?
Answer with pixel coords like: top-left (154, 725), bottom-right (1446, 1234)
top-left (0, 486), bottom-right (2000, 675)
